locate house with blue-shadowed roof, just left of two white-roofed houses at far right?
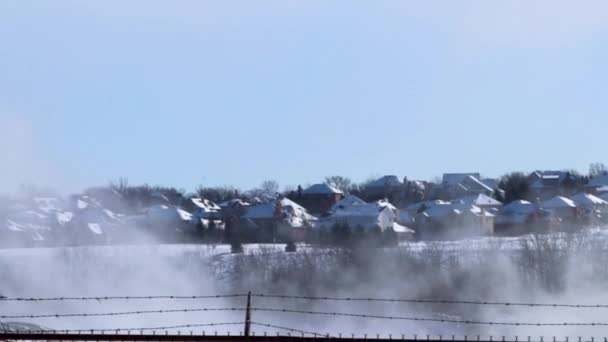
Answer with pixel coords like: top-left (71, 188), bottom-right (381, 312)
top-left (494, 200), bottom-right (546, 235)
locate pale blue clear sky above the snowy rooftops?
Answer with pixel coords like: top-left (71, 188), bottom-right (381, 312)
top-left (0, 0), bottom-right (608, 191)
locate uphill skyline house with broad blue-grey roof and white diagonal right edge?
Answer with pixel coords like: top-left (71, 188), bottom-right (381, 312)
top-left (439, 172), bottom-right (494, 199)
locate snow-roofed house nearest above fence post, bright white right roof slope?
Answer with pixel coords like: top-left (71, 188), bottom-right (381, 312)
top-left (243, 198), bottom-right (317, 241)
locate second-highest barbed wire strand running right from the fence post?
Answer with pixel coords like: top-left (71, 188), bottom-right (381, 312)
top-left (251, 308), bottom-right (608, 327)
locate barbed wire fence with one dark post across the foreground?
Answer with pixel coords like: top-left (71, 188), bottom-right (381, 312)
top-left (0, 293), bottom-right (608, 342)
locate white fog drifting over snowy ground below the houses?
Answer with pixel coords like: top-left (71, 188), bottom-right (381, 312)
top-left (0, 230), bottom-right (608, 339)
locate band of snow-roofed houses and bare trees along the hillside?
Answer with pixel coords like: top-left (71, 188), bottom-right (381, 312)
top-left (0, 171), bottom-right (608, 247)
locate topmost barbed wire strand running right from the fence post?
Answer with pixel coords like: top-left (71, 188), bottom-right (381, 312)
top-left (253, 294), bottom-right (608, 309)
